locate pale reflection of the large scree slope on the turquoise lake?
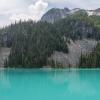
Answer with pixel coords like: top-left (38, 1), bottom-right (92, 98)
top-left (51, 70), bottom-right (99, 95)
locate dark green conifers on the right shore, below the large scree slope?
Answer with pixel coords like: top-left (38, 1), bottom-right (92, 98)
top-left (79, 43), bottom-right (100, 68)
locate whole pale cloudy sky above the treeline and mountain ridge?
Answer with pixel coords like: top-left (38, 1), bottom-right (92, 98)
top-left (0, 0), bottom-right (100, 27)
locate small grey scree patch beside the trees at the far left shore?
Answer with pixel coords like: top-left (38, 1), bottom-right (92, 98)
top-left (0, 47), bottom-right (10, 67)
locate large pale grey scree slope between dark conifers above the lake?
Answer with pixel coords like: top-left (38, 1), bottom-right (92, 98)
top-left (49, 39), bottom-right (97, 67)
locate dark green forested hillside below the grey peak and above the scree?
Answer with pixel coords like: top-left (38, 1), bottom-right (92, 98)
top-left (0, 11), bottom-right (100, 68)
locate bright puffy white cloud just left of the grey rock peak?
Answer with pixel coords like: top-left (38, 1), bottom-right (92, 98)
top-left (10, 0), bottom-right (48, 22)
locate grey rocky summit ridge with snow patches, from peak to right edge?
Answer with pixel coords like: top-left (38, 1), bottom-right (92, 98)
top-left (41, 8), bottom-right (100, 23)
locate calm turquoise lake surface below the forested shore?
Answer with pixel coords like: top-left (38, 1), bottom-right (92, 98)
top-left (0, 70), bottom-right (100, 100)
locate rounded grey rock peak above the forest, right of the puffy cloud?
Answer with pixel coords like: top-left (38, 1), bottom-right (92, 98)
top-left (41, 8), bottom-right (70, 23)
